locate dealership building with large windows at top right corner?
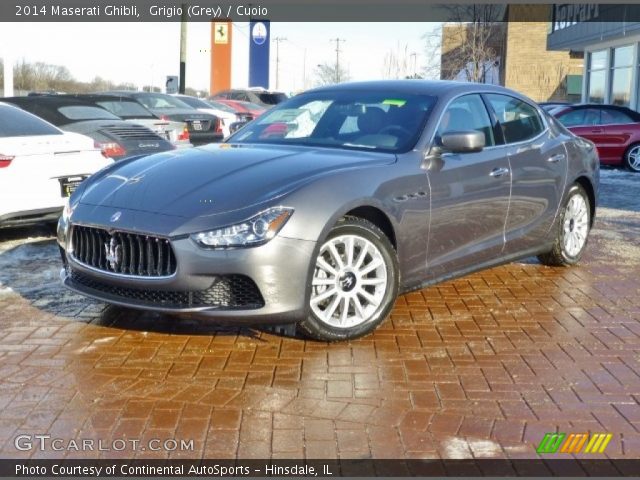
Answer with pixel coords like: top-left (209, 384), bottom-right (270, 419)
top-left (547, 4), bottom-right (640, 110)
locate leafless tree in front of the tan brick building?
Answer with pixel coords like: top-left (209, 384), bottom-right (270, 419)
top-left (425, 4), bottom-right (505, 82)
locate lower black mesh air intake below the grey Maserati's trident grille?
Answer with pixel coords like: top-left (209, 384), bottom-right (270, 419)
top-left (70, 270), bottom-right (264, 310)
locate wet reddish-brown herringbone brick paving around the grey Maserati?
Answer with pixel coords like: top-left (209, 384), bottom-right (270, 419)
top-left (0, 172), bottom-right (640, 458)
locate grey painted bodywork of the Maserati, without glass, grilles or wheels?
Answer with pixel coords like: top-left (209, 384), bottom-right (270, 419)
top-left (58, 81), bottom-right (599, 323)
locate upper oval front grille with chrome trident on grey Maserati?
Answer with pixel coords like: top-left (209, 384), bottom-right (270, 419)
top-left (71, 225), bottom-right (177, 277)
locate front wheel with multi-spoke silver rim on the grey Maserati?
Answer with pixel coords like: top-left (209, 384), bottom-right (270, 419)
top-left (299, 217), bottom-right (399, 342)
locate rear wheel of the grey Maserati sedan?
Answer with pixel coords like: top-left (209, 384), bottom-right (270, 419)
top-left (538, 184), bottom-right (591, 266)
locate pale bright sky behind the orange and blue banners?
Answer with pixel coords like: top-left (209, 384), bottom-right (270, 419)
top-left (0, 22), bottom-right (440, 91)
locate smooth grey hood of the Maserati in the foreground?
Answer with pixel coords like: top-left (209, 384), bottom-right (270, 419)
top-left (80, 144), bottom-right (396, 218)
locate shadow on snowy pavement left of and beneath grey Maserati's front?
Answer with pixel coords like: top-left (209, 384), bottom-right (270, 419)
top-left (0, 236), bottom-right (302, 341)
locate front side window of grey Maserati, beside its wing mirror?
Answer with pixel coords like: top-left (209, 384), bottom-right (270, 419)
top-left (436, 95), bottom-right (495, 146)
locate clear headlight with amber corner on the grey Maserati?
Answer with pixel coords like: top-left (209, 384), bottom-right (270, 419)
top-left (191, 207), bottom-right (293, 248)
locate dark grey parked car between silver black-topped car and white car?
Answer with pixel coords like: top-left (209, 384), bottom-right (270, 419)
top-left (104, 91), bottom-right (224, 146)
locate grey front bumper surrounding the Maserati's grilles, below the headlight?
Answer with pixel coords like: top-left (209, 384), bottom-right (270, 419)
top-left (58, 221), bottom-right (316, 324)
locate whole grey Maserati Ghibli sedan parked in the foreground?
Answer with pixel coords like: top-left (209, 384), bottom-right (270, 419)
top-left (58, 80), bottom-right (599, 341)
